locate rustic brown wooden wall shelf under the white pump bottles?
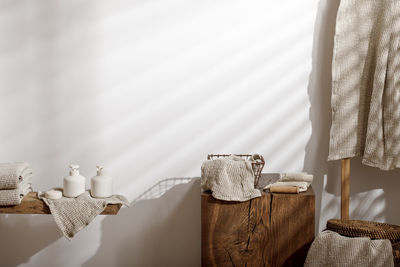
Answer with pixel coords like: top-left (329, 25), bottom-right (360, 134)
top-left (0, 192), bottom-right (122, 215)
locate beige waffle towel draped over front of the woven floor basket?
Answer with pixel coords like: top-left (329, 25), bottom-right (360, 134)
top-left (304, 231), bottom-right (394, 267)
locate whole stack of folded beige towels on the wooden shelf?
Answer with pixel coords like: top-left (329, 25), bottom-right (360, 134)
top-left (0, 162), bottom-right (32, 206)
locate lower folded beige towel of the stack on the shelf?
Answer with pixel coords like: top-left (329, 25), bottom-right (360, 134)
top-left (0, 175), bottom-right (32, 206)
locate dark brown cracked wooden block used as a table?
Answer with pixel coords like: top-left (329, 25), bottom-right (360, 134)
top-left (201, 177), bottom-right (315, 267)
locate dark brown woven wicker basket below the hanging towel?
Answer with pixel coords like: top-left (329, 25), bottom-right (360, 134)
top-left (326, 219), bottom-right (400, 266)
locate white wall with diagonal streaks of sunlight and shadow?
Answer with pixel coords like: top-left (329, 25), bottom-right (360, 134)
top-left (0, 0), bottom-right (400, 267)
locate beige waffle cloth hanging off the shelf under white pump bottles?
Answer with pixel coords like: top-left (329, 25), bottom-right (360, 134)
top-left (38, 191), bottom-right (129, 240)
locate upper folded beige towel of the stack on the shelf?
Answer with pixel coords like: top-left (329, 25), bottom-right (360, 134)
top-left (0, 162), bottom-right (32, 190)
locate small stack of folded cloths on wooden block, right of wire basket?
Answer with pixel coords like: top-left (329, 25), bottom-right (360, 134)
top-left (264, 172), bottom-right (313, 193)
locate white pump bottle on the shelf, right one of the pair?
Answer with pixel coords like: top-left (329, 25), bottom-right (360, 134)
top-left (90, 166), bottom-right (113, 198)
